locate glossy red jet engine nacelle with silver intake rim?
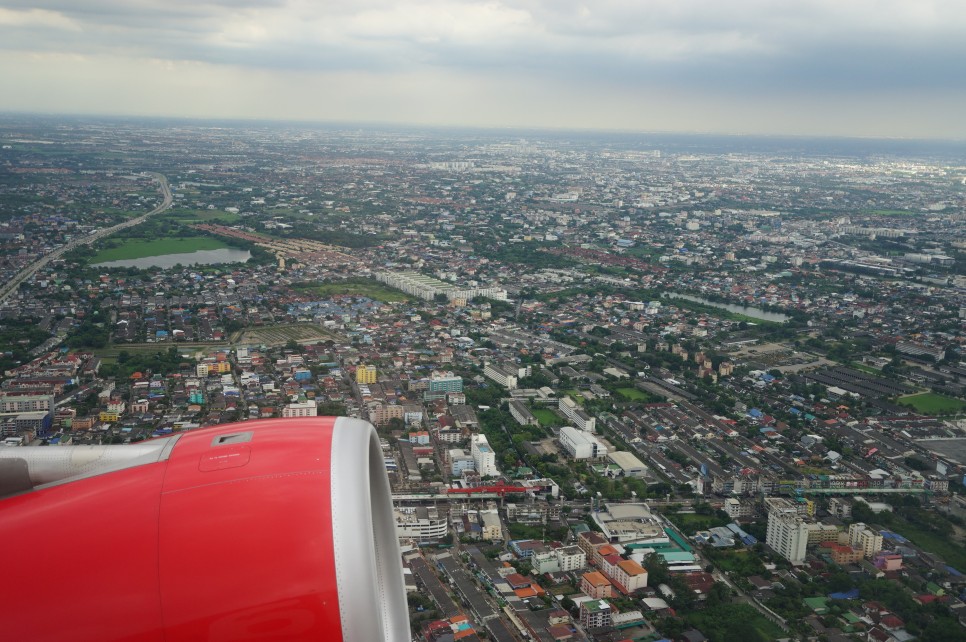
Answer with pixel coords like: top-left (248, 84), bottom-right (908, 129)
top-left (0, 417), bottom-right (410, 642)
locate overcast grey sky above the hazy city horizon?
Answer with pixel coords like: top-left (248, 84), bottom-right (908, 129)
top-left (0, 0), bottom-right (966, 139)
